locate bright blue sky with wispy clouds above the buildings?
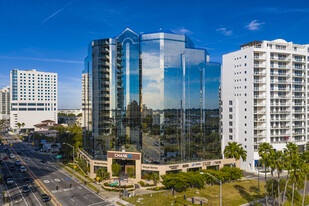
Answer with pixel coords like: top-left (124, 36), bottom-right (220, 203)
top-left (0, 0), bottom-right (309, 108)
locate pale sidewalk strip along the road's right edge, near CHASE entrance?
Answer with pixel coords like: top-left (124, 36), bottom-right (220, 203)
top-left (59, 162), bottom-right (133, 206)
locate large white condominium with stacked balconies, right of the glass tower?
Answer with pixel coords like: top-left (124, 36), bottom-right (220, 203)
top-left (221, 39), bottom-right (309, 171)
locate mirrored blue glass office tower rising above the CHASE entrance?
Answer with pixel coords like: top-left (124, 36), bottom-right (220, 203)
top-left (83, 29), bottom-right (220, 164)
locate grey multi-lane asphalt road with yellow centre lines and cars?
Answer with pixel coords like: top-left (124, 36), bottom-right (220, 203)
top-left (0, 135), bottom-right (113, 206)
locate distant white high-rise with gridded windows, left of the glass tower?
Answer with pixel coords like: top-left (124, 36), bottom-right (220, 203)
top-left (10, 69), bottom-right (58, 130)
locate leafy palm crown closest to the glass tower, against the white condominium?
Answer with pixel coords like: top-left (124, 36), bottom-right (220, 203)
top-left (223, 142), bottom-right (247, 161)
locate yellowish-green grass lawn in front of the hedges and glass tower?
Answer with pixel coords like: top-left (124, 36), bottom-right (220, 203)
top-left (124, 180), bottom-right (265, 206)
